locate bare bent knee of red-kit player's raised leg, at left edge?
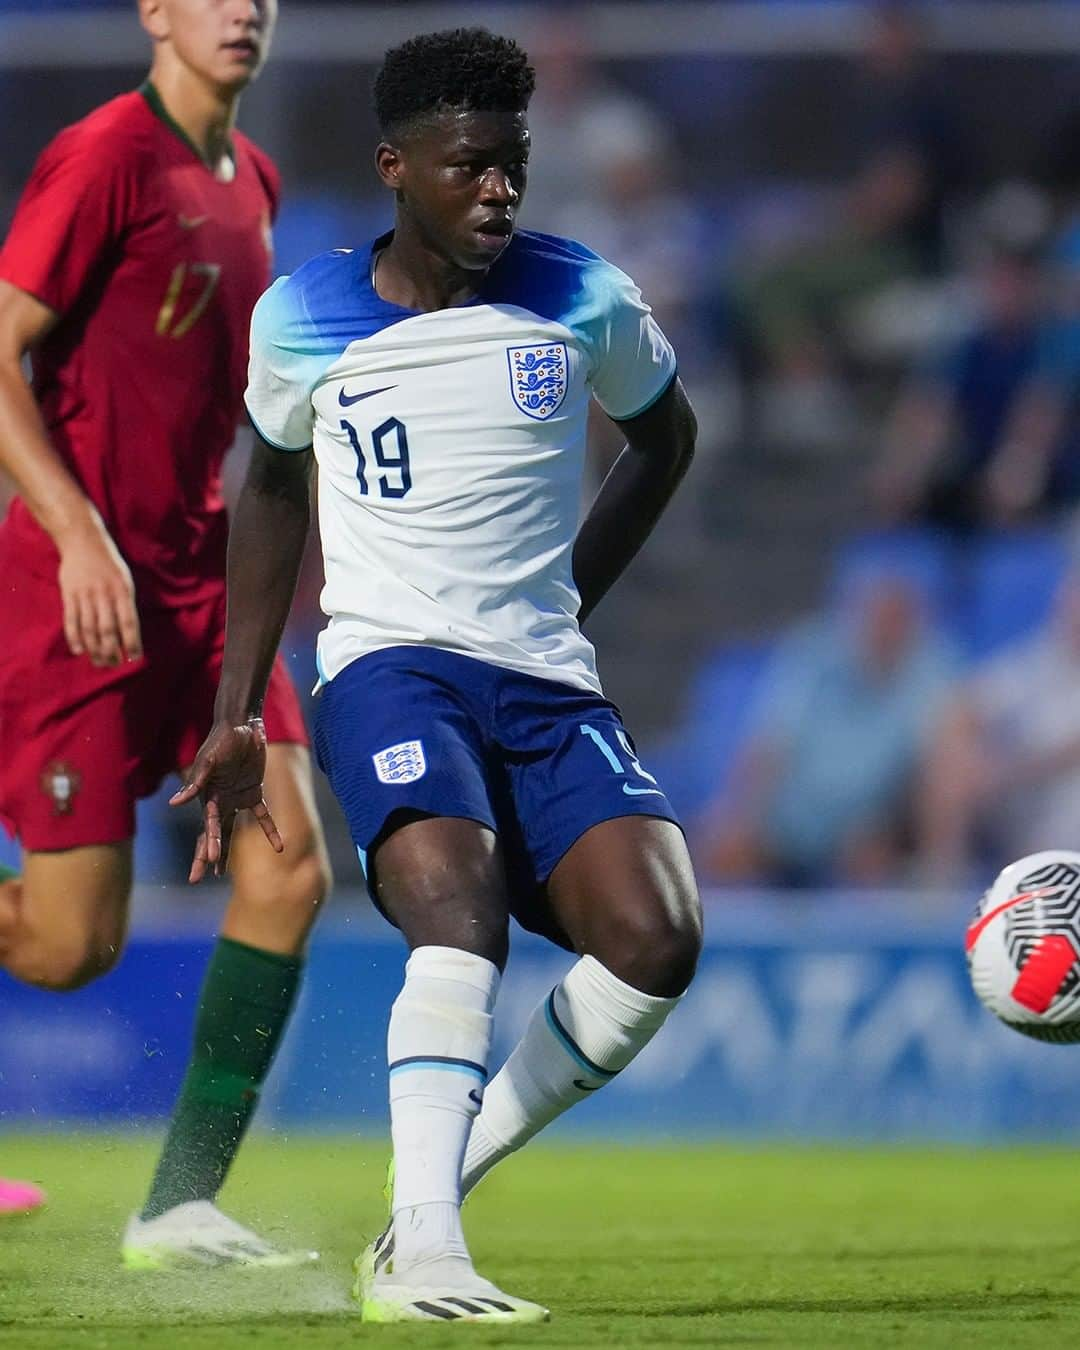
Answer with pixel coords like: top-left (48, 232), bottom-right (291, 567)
top-left (0, 840), bottom-right (131, 991)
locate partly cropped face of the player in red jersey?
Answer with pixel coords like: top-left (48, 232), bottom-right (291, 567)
top-left (139, 0), bottom-right (277, 89)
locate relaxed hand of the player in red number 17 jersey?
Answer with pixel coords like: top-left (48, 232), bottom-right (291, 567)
top-left (58, 516), bottom-right (143, 666)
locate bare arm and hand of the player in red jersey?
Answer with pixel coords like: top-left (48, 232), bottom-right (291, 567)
top-left (0, 281), bottom-right (142, 666)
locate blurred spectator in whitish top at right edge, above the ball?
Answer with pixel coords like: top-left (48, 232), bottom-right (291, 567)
top-left (922, 570), bottom-right (1080, 884)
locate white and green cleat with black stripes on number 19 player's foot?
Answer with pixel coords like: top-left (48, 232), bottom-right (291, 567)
top-left (352, 1252), bottom-right (551, 1324)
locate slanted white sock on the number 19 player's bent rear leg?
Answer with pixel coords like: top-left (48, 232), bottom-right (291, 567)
top-left (462, 956), bottom-right (679, 1196)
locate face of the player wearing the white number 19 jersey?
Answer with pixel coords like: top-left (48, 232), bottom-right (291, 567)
top-left (375, 112), bottom-right (529, 271)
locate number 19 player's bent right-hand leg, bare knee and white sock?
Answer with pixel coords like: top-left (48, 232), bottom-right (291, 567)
top-left (462, 815), bottom-right (701, 1193)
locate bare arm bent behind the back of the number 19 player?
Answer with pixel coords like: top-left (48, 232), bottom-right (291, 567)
top-left (574, 377), bottom-right (698, 622)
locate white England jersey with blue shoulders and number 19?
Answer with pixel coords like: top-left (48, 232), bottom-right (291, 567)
top-left (246, 232), bottom-right (675, 693)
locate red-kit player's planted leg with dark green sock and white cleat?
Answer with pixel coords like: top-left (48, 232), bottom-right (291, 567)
top-left (124, 744), bottom-right (329, 1266)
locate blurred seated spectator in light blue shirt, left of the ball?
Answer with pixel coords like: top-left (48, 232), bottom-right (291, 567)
top-left (694, 564), bottom-right (954, 886)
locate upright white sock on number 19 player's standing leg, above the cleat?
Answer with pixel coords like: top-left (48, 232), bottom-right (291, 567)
top-left (386, 946), bottom-right (500, 1278)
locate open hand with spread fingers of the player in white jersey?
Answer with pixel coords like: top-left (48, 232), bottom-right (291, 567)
top-left (169, 717), bottom-right (285, 883)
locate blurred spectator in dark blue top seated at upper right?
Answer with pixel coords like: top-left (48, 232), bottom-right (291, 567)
top-left (871, 185), bottom-right (1076, 529)
